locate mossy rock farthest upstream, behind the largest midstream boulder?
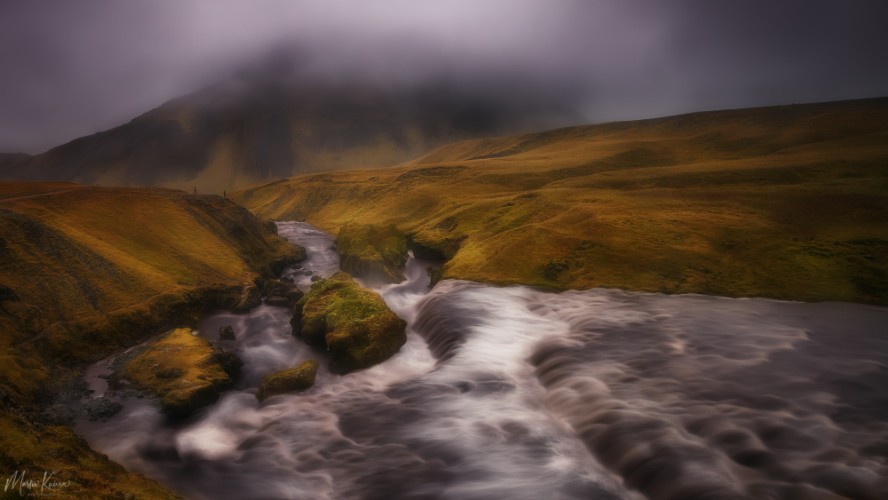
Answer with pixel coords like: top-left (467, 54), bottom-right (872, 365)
top-left (336, 224), bottom-right (407, 283)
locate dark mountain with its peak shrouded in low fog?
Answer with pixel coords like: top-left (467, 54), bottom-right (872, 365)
top-left (0, 73), bottom-right (565, 194)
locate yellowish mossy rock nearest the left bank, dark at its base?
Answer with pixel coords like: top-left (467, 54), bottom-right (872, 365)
top-left (121, 328), bottom-right (242, 417)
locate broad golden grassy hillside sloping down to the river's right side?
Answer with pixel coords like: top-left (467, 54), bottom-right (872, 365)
top-left (235, 99), bottom-right (888, 304)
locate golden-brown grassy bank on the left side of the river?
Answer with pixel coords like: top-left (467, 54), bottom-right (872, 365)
top-left (0, 183), bottom-right (298, 498)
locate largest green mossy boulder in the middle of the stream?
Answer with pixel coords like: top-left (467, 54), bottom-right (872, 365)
top-left (292, 272), bottom-right (407, 372)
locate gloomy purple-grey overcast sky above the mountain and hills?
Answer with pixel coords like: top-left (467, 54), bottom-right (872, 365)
top-left (0, 0), bottom-right (888, 153)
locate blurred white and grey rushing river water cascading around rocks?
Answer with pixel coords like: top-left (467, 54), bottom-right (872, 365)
top-left (77, 223), bottom-right (888, 500)
